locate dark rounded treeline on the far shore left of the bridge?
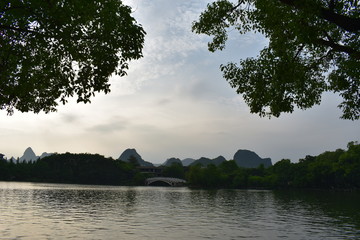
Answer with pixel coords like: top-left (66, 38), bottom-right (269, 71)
top-left (0, 153), bottom-right (143, 185)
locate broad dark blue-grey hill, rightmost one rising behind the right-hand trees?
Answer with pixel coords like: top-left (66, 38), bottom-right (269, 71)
top-left (234, 150), bottom-right (272, 168)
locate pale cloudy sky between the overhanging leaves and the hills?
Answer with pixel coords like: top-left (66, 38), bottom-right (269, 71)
top-left (0, 0), bottom-right (360, 164)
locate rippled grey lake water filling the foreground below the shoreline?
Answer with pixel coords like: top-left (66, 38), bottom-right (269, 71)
top-left (0, 182), bottom-right (360, 240)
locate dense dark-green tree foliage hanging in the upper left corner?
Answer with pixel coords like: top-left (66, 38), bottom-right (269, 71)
top-left (0, 0), bottom-right (145, 113)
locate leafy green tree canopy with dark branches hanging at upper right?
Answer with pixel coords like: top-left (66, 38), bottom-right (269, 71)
top-left (193, 0), bottom-right (360, 120)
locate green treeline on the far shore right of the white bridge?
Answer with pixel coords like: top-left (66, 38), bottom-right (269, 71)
top-left (186, 142), bottom-right (360, 189)
